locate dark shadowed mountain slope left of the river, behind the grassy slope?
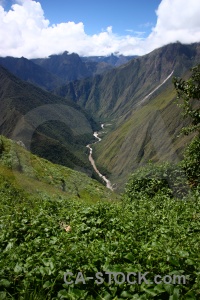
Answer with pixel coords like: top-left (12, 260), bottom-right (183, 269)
top-left (0, 67), bottom-right (95, 173)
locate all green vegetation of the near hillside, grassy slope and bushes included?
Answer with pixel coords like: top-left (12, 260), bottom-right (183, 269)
top-left (0, 56), bottom-right (200, 300)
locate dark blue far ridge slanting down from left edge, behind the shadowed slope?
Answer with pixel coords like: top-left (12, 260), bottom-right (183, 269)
top-left (0, 57), bottom-right (64, 90)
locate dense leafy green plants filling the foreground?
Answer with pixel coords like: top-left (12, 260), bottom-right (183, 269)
top-left (0, 166), bottom-right (200, 300)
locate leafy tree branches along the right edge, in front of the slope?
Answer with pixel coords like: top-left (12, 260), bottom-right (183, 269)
top-left (173, 65), bottom-right (200, 187)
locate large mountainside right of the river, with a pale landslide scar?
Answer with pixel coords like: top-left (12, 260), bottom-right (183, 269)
top-left (54, 43), bottom-right (200, 189)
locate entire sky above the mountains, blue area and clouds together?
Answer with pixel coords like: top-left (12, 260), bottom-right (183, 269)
top-left (0, 0), bottom-right (200, 58)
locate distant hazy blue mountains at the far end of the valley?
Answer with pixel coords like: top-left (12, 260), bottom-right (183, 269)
top-left (0, 51), bottom-right (133, 91)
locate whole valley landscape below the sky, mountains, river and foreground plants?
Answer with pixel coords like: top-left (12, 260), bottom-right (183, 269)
top-left (0, 42), bottom-right (200, 300)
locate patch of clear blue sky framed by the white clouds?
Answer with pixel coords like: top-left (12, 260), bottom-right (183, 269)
top-left (36, 0), bottom-right (161, 35)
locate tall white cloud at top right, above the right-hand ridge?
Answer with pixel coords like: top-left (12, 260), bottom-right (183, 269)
top-left (146, 0), bottom-right (200, 49)
